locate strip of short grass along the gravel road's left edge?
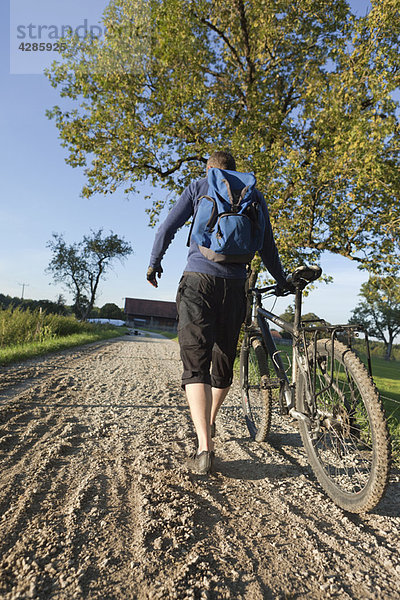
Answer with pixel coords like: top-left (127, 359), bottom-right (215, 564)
top-left (0, 327), bottom-right (128, 366)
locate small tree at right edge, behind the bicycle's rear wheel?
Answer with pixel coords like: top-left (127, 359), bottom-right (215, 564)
top-left (350, 276), bottom-right (400, 360)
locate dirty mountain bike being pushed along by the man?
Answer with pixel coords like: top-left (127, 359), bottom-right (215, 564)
top-left (240, 266), bottom-right (391, 513)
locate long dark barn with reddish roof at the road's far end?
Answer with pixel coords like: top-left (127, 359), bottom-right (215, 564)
top-left (125, 298), bottom-right (177, 331)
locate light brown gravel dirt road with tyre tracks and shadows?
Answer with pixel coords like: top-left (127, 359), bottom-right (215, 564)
top-left (0, 336), bottom-right (400, 600)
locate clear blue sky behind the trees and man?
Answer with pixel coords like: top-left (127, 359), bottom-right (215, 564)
top-left (0, 0), bottom-right (370, 322)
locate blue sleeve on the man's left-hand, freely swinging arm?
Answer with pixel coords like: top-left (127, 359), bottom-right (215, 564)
top-left (149, 184), bottom-right (193, 268)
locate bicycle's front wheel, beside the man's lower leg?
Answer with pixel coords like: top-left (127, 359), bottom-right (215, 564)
top-left (240, 337), bottom-right (272, 442)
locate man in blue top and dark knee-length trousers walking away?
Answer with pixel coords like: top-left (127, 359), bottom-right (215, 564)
top-left (147, 151), bottom-right (287, 474)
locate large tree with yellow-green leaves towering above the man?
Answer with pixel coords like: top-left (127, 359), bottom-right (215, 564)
top-left (48, 0), bottom-right (400, 270)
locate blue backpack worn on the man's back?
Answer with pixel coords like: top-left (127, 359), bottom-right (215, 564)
top-left (187, 168), bottom-right (265, 263)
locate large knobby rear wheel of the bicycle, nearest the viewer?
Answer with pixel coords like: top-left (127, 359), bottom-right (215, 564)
top-left (297, 339), bottom-right (390, 513)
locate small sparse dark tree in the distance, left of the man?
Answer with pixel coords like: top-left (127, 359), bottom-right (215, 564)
top-left (47, 229), bottom-right (132, 320)
